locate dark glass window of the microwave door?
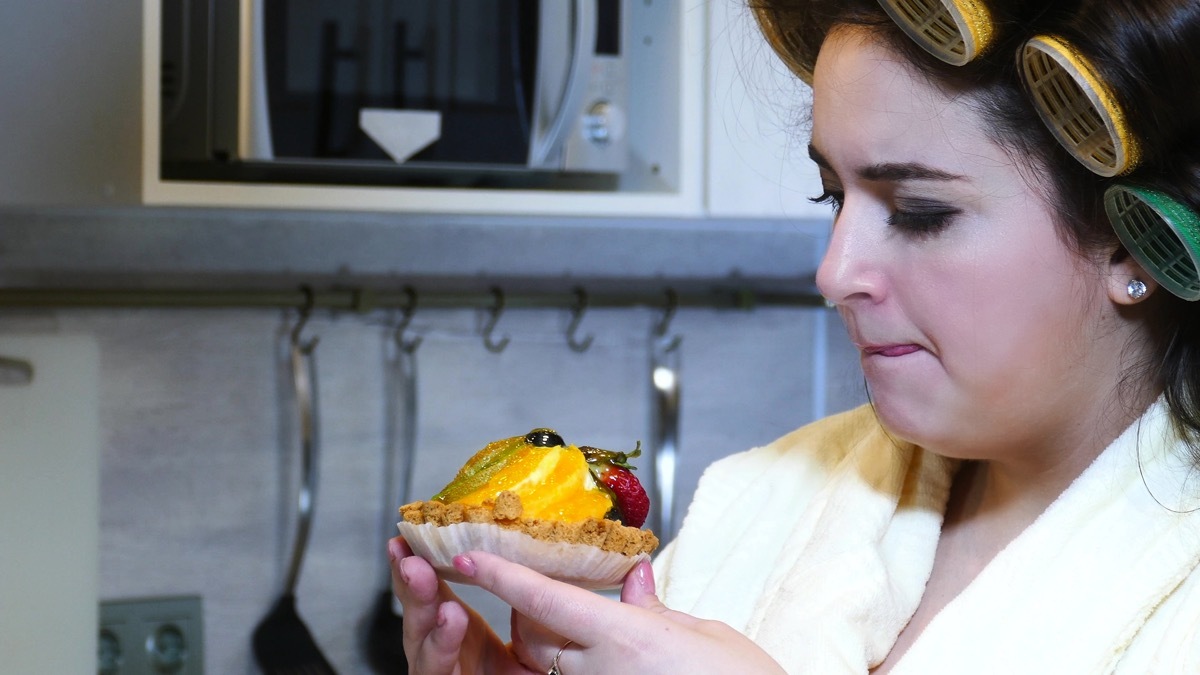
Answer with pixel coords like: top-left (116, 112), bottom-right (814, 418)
top-left (272, 0), bottom-right (538, 165)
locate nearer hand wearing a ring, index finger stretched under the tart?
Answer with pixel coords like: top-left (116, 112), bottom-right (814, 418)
top-left (455, 551), bottom-right (784, 675)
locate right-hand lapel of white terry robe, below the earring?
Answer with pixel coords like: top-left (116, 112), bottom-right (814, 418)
top-left (893, 401), bottom-right (1200, 675)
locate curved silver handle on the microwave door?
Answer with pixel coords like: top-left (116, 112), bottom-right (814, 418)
top-left (529, 0), bottom-right (598, 169)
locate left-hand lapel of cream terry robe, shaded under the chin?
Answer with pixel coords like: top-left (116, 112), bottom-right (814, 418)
top-left (655, 406), bottom-right (956, 675)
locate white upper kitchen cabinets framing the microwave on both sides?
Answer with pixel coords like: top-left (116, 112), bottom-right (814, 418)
top-left (0, 0), bottom-right (826, 219)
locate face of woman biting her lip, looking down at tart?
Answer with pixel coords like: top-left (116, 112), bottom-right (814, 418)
top-left (812, 28), bottom-right (1129, 459)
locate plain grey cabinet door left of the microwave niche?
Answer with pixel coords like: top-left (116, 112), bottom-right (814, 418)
top-left (0, 0), bottom-right (142, 207)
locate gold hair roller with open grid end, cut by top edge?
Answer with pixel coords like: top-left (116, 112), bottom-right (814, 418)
top-left (880, 0), bottom-right (995, 66)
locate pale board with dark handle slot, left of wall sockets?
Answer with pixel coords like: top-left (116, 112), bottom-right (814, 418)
top-left (0, 334), bottom-right (100, 675)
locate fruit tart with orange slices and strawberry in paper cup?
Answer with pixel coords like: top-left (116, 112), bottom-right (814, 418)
top-left (398, 429), bottom-right (659, 589)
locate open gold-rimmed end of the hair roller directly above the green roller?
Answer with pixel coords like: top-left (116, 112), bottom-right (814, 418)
top-left (1020, 35), bottom-right (1140, 177)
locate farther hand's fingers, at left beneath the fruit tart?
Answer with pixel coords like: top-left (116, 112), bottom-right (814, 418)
top-left (388, 537), bottom-right (535, 675)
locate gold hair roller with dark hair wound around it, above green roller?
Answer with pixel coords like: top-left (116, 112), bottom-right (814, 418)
top-left (1018, 0), bottom-right (1200, 177)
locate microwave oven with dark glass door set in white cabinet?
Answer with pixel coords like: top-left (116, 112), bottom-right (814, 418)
top-left (160, 0), bottom-right (630, 187)
